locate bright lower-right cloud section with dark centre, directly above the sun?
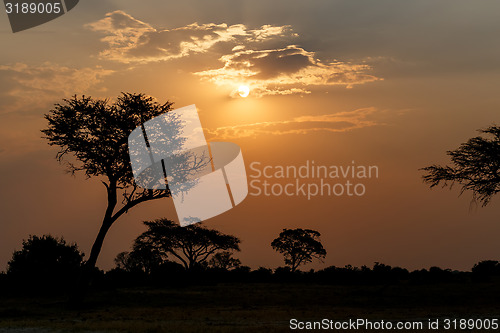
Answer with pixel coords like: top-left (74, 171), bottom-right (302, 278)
top-left (195, 45), bottom-right (381, 97)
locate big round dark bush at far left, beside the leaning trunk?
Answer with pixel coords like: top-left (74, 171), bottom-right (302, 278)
top-left (7, 235), bottom-right (84, 288)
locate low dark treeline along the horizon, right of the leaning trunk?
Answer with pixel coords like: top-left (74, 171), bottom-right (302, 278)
top-left (96, 261), bottom-right (500, 287)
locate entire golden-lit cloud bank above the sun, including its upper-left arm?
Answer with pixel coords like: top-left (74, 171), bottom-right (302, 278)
top-left (86, 10), bottom-right (382, 97)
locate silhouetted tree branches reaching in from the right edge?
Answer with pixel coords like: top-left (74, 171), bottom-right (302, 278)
top-left (422, 126), bottom-right (500, 206)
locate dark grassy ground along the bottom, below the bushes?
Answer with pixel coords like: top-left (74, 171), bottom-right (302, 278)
top-left (0, 281), bottom-right (500, 333)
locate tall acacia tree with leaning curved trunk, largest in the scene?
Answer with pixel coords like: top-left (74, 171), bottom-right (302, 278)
top-left (42, 93), bottom-right (196, 301)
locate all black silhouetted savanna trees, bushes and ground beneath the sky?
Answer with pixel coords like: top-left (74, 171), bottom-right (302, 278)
top-left (0, 93), bottom-right (500, 333)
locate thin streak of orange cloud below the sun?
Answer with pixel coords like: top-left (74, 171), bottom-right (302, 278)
top-left (207, 107), bottom-right (386, 140)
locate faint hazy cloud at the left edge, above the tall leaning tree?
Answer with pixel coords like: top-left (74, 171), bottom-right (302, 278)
top-left (0, 62), bottom-right (113, 113)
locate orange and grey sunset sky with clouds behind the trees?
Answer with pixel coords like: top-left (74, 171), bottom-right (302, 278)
top-left (0, 0), bottom-right (500, 270)
